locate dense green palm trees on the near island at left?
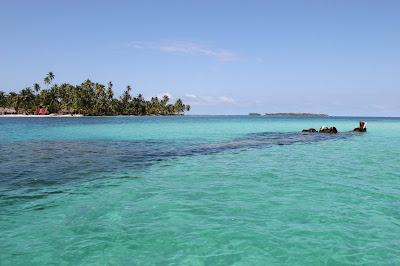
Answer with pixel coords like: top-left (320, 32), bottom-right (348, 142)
top-left (0, 72), bottom-right (190, 116)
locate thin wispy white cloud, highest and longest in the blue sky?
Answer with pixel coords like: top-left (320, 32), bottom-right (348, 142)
top-left (129, 41), bottom-right (239, 62)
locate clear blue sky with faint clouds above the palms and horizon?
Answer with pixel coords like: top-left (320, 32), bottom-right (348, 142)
top-left (0, 0), bottom-right (400, 117)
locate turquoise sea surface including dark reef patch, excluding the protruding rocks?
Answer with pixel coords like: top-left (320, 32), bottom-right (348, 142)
top-left (0, 116), bottom-right (400, 265)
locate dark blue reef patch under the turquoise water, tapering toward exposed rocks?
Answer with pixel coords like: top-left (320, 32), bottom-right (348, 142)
top-left (0, 132), bottom-right (358, 206)
